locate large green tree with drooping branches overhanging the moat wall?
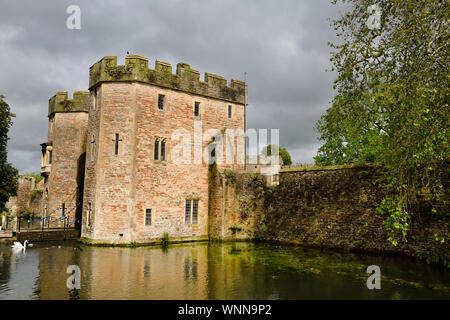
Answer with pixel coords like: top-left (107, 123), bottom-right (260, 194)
top-left (315, 0), bottom-right (450, 244)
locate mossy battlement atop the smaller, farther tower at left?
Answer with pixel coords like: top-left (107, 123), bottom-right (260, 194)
top-left (48, 91), bottom-right (90, 117)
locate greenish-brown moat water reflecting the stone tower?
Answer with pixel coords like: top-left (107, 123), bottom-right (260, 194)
top-left (0, 242), bottom-right (450, 299)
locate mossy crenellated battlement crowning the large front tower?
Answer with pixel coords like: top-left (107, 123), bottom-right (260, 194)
top-left (89, 54), bottom-right (246, 104)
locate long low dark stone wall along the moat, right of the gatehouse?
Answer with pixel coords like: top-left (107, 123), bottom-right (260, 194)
top-left (210, 167), bottom-right (450, 261)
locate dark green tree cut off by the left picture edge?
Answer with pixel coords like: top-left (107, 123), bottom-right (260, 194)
top-left (0, 95), bottom-right (18, 212)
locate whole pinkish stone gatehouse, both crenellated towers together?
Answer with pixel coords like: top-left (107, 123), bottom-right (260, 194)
top-left (43, 54), bottom-right (246, 243)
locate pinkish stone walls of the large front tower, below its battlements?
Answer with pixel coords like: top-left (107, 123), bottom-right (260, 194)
top-left (82, 66), bottom-right (245, 244)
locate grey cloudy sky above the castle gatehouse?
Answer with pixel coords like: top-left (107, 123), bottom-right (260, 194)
top-left (0, 0), bottom-right (339, 173)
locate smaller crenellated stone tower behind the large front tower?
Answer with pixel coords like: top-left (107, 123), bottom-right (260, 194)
top-left (41, 91), bottom-right (90, 226)
